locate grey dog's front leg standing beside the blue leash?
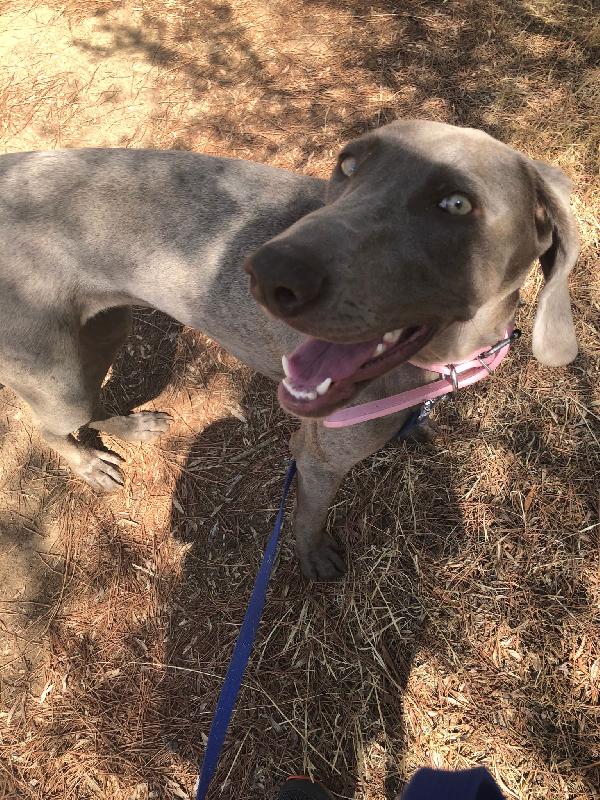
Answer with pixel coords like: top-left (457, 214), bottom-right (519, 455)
top-left (290, 412), bottom-right (407, 581)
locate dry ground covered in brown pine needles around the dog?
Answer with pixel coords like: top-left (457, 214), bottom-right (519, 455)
top-left (0, 0), bottom-right (600, 800)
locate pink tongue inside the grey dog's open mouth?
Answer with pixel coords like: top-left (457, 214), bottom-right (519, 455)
top-left (288, 337), bottom-right (379, 389)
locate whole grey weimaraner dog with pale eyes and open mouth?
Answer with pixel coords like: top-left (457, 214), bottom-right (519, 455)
top-left (0, 120), bottom-right (578, 580)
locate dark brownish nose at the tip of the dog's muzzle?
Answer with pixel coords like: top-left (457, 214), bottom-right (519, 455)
top-left (245, 242), bottom-right (325, 317)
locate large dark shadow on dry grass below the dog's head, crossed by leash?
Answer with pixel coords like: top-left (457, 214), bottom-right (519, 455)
top-left (161, 377), bottom-right (472, 800)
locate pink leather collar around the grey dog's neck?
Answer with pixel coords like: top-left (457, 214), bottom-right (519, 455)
top-left (323, 325), bottom-right (521, 428)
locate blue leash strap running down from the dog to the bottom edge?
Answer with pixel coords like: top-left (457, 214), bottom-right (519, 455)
top-left (196, 461), bottom-right (296, 800)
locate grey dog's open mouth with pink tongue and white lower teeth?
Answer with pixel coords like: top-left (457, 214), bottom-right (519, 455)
top-left (278, 325), bottom-right (434, 417)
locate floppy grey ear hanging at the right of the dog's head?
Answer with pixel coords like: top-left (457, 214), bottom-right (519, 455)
top-left (532, 161), bottom-right (579, 367)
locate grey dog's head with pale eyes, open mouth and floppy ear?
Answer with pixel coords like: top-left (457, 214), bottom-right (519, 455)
top-left (246, 121), bottom-right (578, 416)
